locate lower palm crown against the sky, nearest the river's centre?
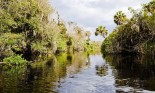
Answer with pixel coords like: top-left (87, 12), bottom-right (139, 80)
top-left (95, 26), bottom-right (108, 38)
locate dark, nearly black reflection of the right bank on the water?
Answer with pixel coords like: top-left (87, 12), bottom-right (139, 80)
top-left (104, 55), bottom-right (155, 92)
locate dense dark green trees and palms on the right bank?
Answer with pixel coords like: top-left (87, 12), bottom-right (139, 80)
top-left (100, 0), bottom-right (155, 55)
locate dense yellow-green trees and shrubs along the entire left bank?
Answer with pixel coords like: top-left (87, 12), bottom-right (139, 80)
top-left (0, 0), bottom-right (100, 65)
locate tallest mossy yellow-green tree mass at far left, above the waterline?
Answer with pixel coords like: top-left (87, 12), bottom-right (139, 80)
top-left (0, 0), bottom-right (58, 54)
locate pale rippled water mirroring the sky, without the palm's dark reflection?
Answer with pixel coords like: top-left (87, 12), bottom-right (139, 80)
top-left (57, 54), bottom-right (116, 93)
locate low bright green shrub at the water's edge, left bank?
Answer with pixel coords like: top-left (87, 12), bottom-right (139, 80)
top-left (3, 55), bottom-right (27, 65)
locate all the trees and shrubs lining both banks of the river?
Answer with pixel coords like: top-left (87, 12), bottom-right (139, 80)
top-left (0, 0), bottom-right (155, 65)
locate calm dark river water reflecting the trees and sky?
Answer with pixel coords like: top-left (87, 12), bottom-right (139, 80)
top-left (0, 53), bottom-right (155, 93)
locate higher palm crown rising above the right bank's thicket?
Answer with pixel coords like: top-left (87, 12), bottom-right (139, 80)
top-left (114, 11), bottom-right (127, 25)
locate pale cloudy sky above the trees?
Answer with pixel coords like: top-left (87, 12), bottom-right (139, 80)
top-left (50, 0), bottom-right (151, 41)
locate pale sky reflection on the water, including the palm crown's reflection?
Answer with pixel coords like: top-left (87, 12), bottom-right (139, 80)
top-left (57, 54), bottom-right (115, 93)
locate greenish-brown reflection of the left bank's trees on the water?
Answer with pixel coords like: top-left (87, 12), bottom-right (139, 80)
top-left (0, 53), bottom-right (87, 93)
